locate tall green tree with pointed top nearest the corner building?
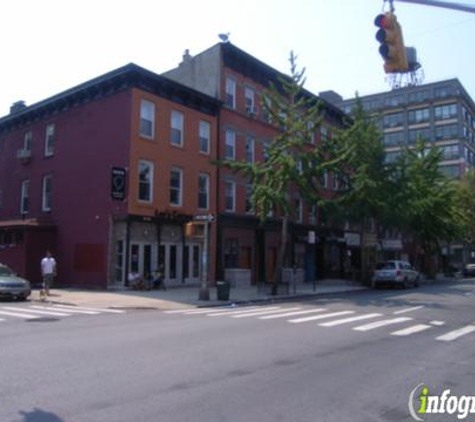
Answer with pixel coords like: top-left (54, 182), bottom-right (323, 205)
top-left (218, 52), bottom-right (346, 294)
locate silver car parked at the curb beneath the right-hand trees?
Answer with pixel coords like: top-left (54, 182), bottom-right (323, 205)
top-left (372, 260), bottom-right (420, 288)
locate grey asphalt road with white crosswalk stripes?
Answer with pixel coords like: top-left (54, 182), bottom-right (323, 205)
top-left (0, 281), bottom-right (475, 422)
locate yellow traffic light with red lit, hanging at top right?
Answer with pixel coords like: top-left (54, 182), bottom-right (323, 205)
top-left (374, 12), bottom-right (408, 73)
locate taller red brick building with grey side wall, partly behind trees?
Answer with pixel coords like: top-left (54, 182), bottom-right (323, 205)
top-left (164, 42), bottom-right (359, 283)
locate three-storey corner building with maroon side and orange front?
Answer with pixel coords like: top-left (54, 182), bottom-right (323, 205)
top-left (0, 64), bottom-right (220, 288)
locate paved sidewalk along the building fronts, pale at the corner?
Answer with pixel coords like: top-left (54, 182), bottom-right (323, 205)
top-left (30, 280), bottom-right (367, 310)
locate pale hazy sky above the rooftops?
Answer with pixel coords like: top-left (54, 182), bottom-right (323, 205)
top-left (0, 0), bottom-right (475, 116)
